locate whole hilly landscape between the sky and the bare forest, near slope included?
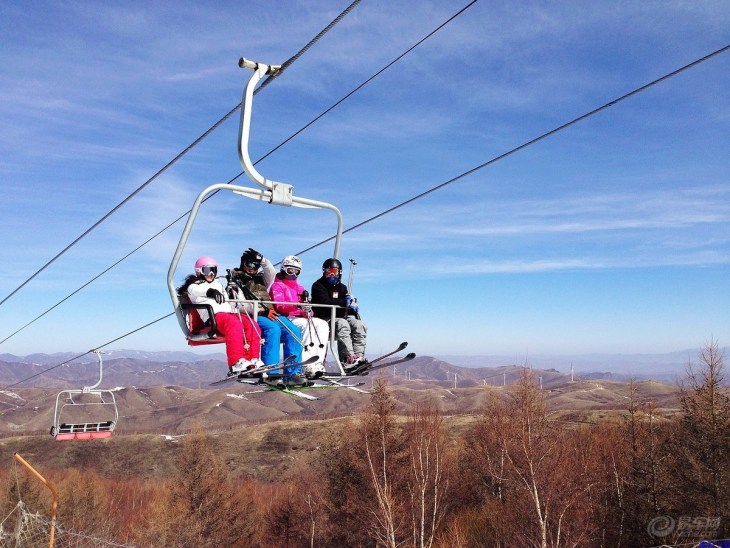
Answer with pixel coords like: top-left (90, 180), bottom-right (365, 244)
top-left (0, 351), bottom-right (704, 486)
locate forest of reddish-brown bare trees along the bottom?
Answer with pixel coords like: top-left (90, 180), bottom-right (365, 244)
top-left (3, 342), bottom-right (730, 548)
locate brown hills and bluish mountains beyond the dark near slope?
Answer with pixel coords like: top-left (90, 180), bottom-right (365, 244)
top-left (0, 356), bottom-right (678, 444)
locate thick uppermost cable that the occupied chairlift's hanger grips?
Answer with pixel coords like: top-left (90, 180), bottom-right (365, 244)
top-left (0, 0), bottom-right (361, 306)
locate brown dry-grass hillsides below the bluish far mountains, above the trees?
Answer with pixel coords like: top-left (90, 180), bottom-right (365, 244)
top-left (0, 374), bottom-right (678, 481)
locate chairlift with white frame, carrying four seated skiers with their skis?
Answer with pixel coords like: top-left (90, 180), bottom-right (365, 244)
top-left (167, 58), bottom-right (414, 398)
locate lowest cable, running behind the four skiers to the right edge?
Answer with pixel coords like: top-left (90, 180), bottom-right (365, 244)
top-left (6, 44), bottom-right (730, 388)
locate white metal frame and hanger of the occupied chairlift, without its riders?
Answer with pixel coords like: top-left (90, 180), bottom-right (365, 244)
top-left (167, 57), bottom-right (344, 373)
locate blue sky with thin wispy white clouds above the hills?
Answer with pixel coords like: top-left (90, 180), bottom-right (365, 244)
top-left (0, 0), bottom-right (730, 357)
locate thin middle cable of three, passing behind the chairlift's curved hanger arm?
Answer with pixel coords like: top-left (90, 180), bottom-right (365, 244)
top-left (0, 0), bottom-right (477, 344)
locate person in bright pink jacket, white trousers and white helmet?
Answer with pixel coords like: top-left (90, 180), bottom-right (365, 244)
top-left (270, 255), bottom-right (329, 378)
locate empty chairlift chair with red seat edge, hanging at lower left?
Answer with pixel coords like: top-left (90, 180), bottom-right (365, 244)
top-left (51, 350), bottom-right (119, 441)
